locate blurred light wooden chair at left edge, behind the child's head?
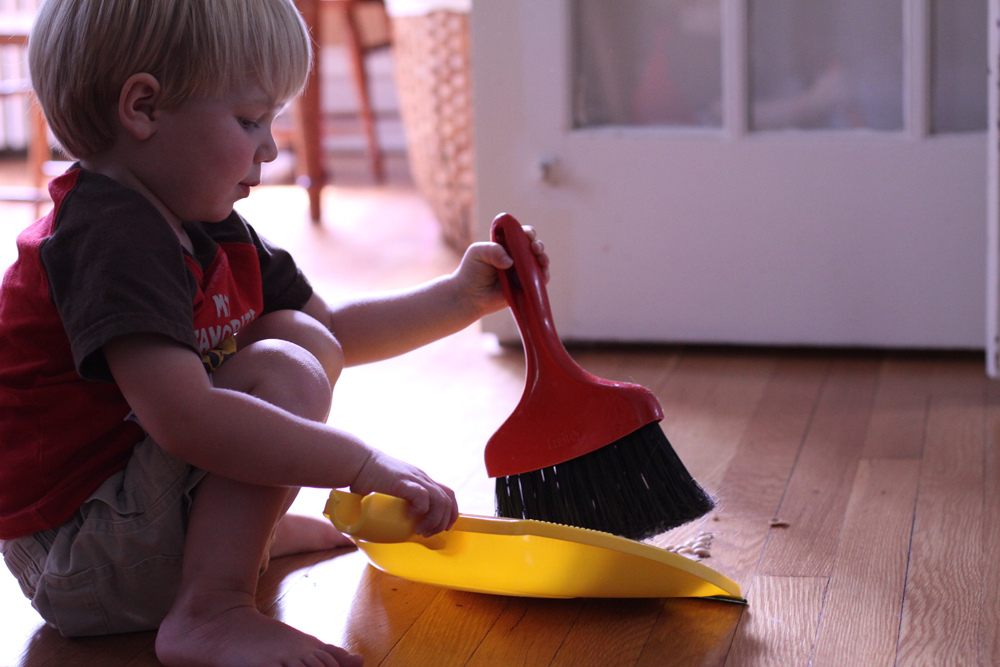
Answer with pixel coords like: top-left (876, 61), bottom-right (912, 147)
top-left (0, 12), bottom-right (52, 212)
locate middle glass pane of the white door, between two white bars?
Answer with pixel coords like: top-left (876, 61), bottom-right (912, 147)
top-left (748, 0), bottom-right (908, 130)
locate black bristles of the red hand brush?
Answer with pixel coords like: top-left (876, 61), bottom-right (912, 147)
top-left (496, 422), bottom-right (715, 540)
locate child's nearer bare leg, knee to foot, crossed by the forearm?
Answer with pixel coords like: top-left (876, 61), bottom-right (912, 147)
top-left (156, 340), bottom-right (361, 667)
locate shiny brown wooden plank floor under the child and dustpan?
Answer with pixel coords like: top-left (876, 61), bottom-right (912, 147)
top-left (0, 163), bottom-right (1000, 667)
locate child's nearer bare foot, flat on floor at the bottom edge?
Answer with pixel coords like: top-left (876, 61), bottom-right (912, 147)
top-left (156, 592), bottom-right (363, 667)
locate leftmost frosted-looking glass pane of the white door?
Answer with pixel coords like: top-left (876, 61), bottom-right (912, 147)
top-left (573, 0), bottom-right (722, 127)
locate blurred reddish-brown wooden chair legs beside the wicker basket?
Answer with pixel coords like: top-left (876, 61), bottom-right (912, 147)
top-left (295, 0), bottom-right (391, 224)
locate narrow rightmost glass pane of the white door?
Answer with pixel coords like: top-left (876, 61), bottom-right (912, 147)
top-left (931, 0), bottom-right (988, 133)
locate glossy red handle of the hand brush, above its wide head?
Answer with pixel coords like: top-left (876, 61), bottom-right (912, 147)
top-left (491, 213), bottom-right (589, 378)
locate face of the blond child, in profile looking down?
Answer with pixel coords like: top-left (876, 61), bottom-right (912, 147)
top-left (144, 85), bottom-right (281, 222)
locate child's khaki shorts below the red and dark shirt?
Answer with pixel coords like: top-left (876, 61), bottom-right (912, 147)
top-left (0, 438), bottom-right (205, 637)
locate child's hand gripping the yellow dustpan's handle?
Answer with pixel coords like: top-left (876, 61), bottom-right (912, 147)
top-left (351, 450), bottom-right (458, 537)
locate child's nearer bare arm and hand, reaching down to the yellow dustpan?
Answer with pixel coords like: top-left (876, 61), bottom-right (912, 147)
top-left (104, 334), bottom-right (458, 535)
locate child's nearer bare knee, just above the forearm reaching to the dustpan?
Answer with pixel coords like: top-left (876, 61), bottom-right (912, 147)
top-left (213, 338), bottom-right (333, 421)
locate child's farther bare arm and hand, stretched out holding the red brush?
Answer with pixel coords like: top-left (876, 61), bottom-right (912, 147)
top-left (303, 227), bottom-right (549, 366)
